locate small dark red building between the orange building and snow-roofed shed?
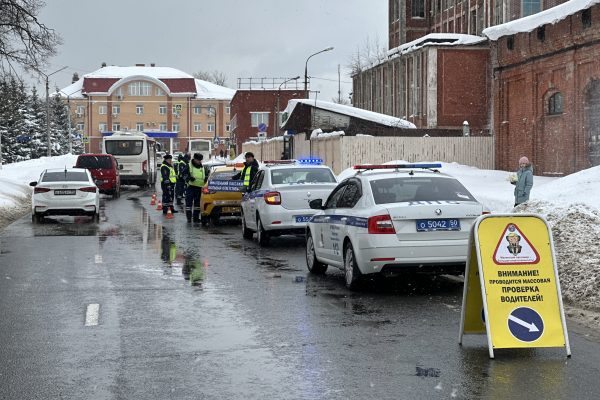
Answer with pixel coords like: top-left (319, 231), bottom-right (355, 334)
top-left (231, 78), bottom-right (307, 151)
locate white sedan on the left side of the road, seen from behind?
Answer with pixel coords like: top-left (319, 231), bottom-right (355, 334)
top-left (29, 168), bottom-right (100, 222)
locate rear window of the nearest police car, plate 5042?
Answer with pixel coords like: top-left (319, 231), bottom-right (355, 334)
top-left (371, 177), bottom-right (476, 204)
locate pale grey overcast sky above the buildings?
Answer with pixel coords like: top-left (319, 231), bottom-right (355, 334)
top-left (32, 0), bottom-right (387, 100)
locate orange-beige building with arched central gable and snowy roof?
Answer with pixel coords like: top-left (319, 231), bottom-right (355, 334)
top-left (57, 64), bottom-right (235, 152)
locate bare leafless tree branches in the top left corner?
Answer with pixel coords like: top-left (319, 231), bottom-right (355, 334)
top-left (0, 0), bottom-right (61, 74)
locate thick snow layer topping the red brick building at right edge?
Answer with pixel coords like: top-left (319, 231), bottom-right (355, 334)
top-left (483, 0), bottom-right (600, 41)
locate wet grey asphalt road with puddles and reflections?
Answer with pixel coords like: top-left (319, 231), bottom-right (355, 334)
top-left (0, 190), bottom-right (600, 399)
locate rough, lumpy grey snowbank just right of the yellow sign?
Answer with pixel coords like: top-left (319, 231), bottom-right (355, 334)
top-left (516, 202), bottom-right (600, 311)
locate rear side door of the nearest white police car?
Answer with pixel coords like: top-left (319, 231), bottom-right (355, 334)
top-left (330, 178), bottom-right (362, 263)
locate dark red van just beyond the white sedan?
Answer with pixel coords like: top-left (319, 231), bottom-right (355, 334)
top-left (75, 154), bottom-right (121, 197)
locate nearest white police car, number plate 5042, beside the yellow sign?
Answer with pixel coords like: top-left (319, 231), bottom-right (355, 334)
top-left (306, 164), bottom-right (484, 290)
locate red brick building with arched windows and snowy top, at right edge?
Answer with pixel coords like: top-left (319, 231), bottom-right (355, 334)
top-left (484, 0), bottom-right (600, 175)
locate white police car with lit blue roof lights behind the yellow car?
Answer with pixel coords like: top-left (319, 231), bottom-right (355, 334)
top-left (241, 159), bottom-right (337, 246)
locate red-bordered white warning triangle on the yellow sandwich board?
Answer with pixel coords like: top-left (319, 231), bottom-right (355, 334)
top-left (494, 224), bottom-right (540, 265)
